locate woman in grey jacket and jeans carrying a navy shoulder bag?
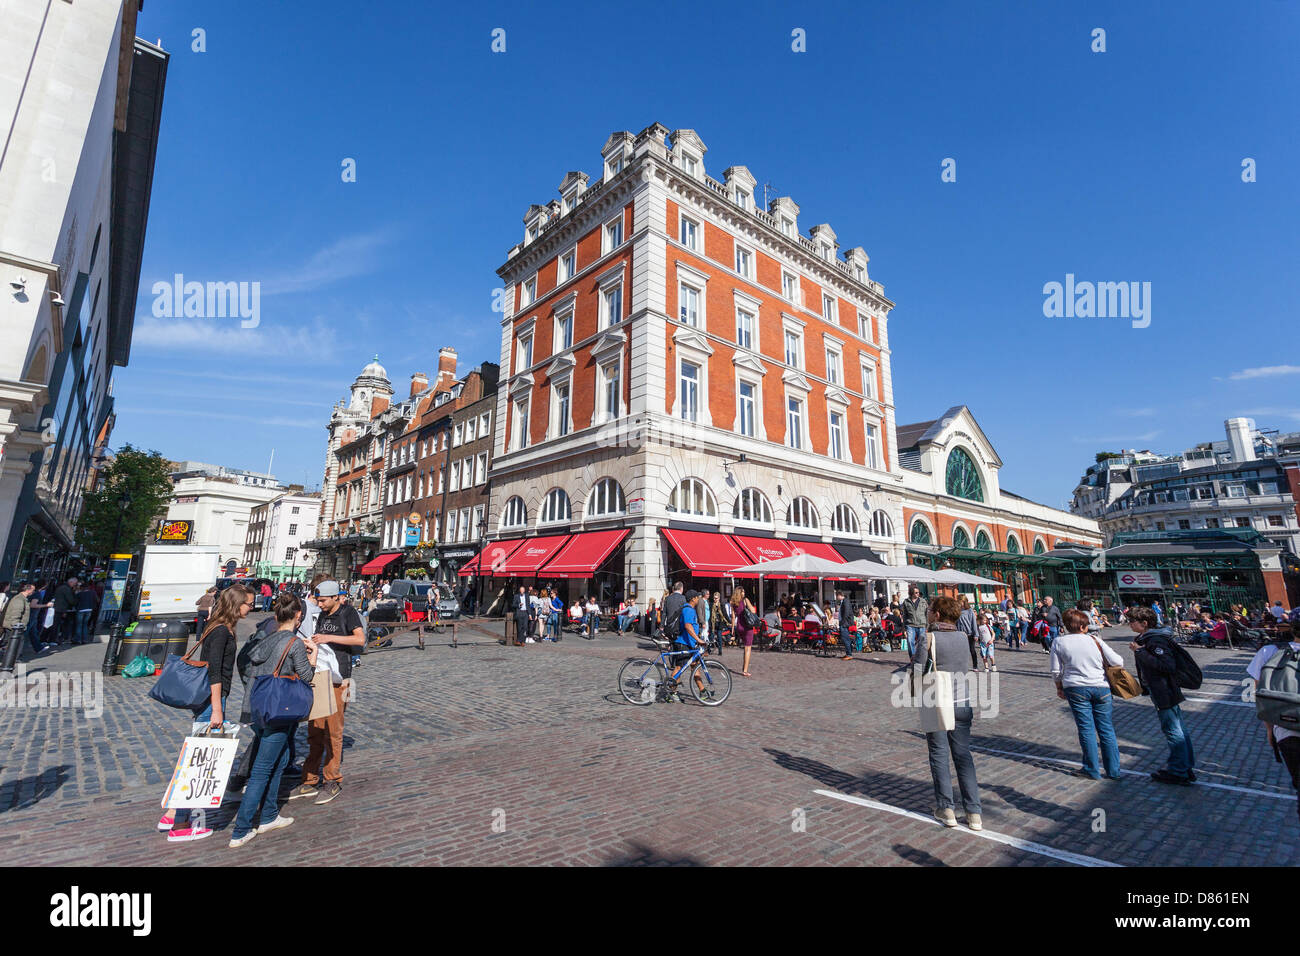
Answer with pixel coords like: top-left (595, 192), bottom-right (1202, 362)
top-left (230, 591), bottom-right (319, 848)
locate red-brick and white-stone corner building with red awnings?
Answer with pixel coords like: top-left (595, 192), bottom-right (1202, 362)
top-left (488, 124), bottom-right (1095, 600)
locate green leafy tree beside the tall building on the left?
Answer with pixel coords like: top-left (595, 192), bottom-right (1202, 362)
top-left (77, 445), bottom-right (172, 555)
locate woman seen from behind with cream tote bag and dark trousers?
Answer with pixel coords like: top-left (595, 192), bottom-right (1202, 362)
top-left (911, 596), bottom-right (984, 830)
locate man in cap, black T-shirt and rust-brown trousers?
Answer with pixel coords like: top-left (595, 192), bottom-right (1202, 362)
top-left (289, 581), bottom-right (365, 805)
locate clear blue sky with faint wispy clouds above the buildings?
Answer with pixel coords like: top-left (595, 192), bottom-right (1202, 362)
top-left (113, 0), bottom-right (1300, 506)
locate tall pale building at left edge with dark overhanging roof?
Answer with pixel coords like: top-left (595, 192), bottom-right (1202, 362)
top-left (0, 0), bottom-right (168, 579)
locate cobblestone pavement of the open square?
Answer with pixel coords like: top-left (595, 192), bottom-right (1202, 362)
top-left (0, 620), bottom-right (1300, 866)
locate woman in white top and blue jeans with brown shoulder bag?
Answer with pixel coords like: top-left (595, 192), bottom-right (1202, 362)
top-left (1052, 609), bottom-right (1125, 780)
